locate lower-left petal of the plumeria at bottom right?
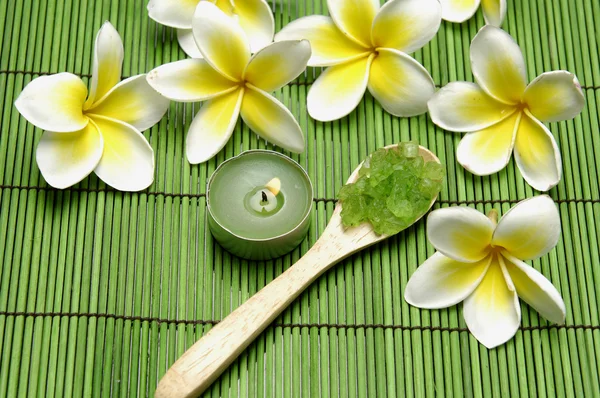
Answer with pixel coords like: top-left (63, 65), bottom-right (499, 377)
top-left (404, 252), bottom-right (491, 308)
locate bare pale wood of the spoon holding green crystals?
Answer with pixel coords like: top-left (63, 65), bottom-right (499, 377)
top-left (155, 145), bottom-right (440, 398)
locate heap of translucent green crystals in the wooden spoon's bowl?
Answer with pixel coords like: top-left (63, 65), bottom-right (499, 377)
top-left (338, 141), bottom-right (445, 235)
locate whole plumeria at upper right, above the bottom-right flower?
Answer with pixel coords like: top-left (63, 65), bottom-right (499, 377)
top-left (429, 25), bottom-right (585, 191)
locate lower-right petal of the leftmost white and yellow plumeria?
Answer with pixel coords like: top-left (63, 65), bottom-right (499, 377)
top-left (93, 116), bottom-right (154, 192)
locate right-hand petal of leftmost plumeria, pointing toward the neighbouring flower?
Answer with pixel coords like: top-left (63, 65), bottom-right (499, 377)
top-left (88, 75), bottom-right (169, 131)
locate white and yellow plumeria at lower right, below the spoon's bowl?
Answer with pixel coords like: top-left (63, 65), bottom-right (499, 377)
top-left (404, 195), bottom-right (565, 348)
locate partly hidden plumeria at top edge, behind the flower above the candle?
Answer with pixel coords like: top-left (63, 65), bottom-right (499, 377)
top-left (148, 0), bottom-right (275, 58)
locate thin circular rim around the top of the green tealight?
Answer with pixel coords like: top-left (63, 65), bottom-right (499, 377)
top-left (206, 149), bottom-right (314, 242)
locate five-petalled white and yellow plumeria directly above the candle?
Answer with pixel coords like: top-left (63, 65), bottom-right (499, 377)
top-left (147, 1), bottom-right (310, 164)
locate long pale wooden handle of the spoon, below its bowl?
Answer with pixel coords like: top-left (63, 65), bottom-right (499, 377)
top-left (155, 239), bottom-right (342, 398)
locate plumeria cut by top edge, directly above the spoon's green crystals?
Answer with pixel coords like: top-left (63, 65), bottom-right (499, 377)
top-left (275, 0), bottom-right (441, 121)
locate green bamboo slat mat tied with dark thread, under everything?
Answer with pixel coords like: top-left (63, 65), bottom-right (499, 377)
top-left (0, 0), bottom-right (600, 397)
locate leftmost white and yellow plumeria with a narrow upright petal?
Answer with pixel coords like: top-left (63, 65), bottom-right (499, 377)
top-left (15, 22), bottom-right (169, 191)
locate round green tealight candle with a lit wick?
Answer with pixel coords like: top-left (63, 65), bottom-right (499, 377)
top-left (207, 150), bottom-right (313, 260)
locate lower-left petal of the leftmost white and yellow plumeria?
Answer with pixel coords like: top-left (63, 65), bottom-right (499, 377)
top-left (35, 122), bottom-right (103, 189)
